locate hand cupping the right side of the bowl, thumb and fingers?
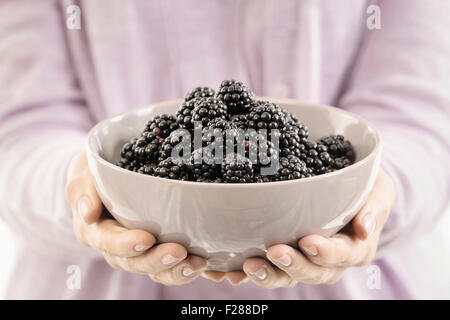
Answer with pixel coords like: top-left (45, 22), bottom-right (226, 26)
top-left (226, 170), bottom-right (395, 288)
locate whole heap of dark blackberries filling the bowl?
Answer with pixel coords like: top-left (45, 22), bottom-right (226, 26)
top-left (118, 80), bottom-right (355, 183)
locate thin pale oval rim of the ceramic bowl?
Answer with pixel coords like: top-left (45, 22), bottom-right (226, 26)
top-left (85, 96), bottom-right (382, 188)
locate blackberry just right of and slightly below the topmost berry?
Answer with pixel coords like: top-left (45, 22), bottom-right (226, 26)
top-left (247, 102), bottom-right (286, 130)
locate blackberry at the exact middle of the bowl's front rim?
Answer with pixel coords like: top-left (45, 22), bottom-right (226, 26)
top-left (222, 155), bottom-right (254, 183)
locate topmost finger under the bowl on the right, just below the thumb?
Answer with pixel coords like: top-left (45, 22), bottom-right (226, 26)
top-left (298, 233), bottom-right (368, 268)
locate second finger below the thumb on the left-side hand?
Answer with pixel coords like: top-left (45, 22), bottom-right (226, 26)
top-left (118, 243), bottom-right (187, 275)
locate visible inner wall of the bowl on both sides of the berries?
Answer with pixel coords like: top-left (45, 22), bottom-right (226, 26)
top-left (88, 99), bottom-right (379, 168)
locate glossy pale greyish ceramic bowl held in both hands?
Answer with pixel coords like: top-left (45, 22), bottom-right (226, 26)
top-left (86, 98), bottom-right (381, 271)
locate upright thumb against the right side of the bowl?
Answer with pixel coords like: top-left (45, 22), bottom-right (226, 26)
top-left (352, 170), bottom-right (395, 240)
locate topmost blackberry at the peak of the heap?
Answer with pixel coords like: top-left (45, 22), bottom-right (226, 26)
top-left (216, 80), bottom-right (254, 114)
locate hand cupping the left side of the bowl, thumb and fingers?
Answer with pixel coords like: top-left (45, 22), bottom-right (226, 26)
top-left (66, 153), bottom-right (206, 285)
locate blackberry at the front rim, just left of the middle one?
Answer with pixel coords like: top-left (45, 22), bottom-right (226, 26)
top-left (186, 148), bottom-right (220, 182)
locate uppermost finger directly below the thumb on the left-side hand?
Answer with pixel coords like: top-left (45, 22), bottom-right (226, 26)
top-left (75, 217), bottom-right (156, 257)
